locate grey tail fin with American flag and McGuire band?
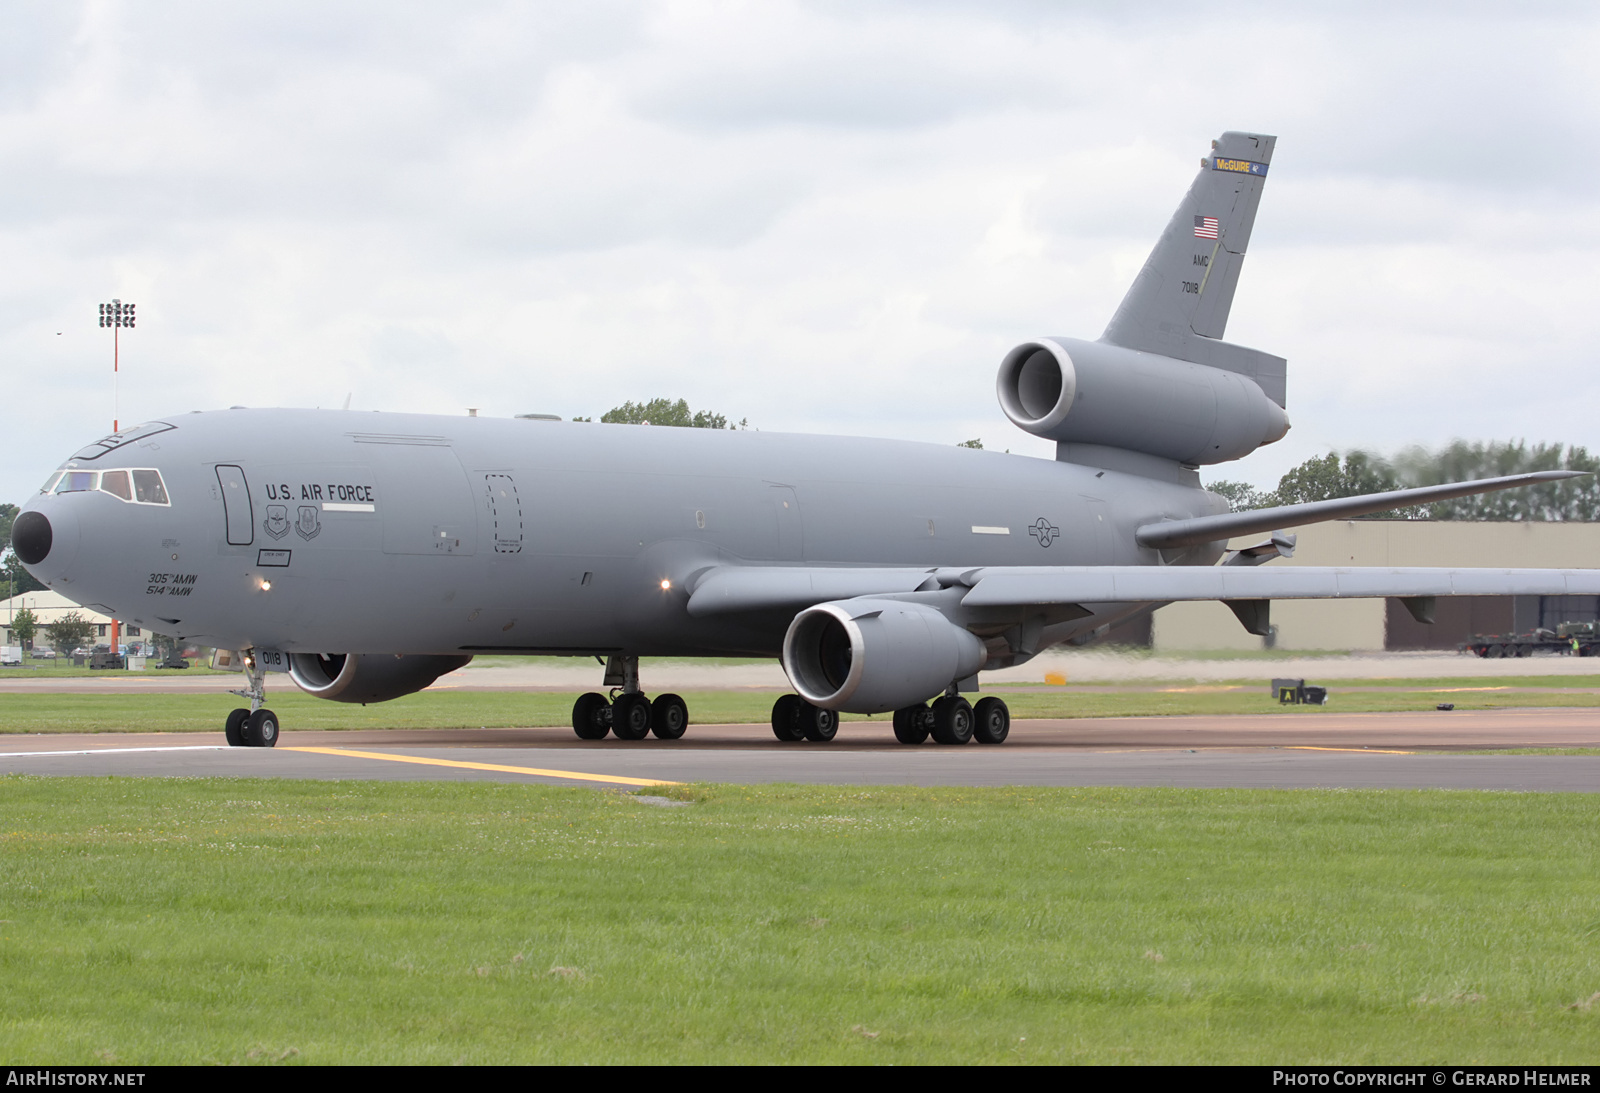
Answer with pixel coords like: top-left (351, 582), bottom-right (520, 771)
top-left (1101, 133), bottom-right (1285, 406)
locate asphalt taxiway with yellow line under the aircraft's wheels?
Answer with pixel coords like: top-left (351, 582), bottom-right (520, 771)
top-left (0, 709), bottom-right (1600, 792)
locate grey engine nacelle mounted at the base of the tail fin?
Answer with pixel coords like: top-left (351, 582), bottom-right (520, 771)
top-left (997, 338), bottom-right (1290, 466)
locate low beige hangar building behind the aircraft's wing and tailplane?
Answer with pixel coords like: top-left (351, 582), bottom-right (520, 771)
top-left (1149, 520), bottom-right (1600, 651)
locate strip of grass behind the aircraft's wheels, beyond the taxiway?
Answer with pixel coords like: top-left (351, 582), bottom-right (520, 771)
top-left (0, 677), bottom-right (1600, 735)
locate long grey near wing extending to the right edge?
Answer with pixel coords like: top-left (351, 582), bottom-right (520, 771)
top-left (688, 565), bottom-right (1600, 616)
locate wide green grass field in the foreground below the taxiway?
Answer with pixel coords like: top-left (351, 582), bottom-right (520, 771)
top-left (0, 776), bottom-right (1600, 1064)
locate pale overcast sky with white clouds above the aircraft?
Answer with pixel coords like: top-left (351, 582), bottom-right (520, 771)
top-left (0, 0), bottom-right (1600, 501)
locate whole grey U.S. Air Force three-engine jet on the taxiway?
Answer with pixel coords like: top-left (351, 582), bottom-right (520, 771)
top-left (13, 133), bottom-right (1600, 747)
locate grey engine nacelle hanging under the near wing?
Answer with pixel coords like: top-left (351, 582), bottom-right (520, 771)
top-left (784, 600), bottom-right (989, 714)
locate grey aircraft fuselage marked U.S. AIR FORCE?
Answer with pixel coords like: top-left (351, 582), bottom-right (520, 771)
top-left (18, 410), bottom-right (1219, 656)
